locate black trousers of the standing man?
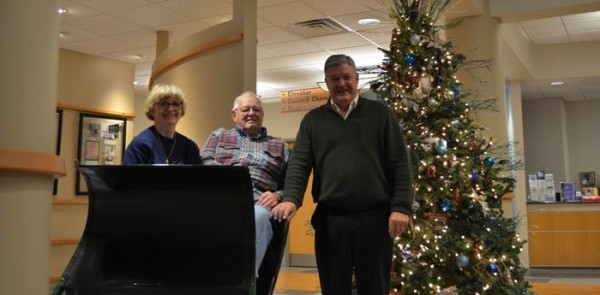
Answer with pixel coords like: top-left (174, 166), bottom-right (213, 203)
top-left (311, 205), bottom-right (392, 295)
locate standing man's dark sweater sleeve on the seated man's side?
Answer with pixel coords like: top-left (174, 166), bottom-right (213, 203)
top-left (282, 116), bottom-right (313, 208)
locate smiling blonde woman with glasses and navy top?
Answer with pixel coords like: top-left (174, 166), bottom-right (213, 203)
top-left (123, 84), bottom-right (201, 165)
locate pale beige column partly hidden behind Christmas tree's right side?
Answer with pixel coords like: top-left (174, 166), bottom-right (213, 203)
top-left (447, 9), bottom-right (529, 267)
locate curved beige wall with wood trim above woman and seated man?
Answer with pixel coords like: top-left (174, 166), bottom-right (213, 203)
top-left (153, 0), bottom-right (257, 146)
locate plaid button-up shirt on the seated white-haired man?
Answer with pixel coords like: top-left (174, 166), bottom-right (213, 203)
top-left (200, 126), bottom-right (290, 200)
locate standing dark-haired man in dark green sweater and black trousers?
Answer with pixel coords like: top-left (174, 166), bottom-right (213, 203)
top-left (272, 54), bottom-right (412, 295)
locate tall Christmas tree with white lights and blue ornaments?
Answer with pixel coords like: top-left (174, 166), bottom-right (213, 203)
top-left (372, 0), bottom-right (531, 295)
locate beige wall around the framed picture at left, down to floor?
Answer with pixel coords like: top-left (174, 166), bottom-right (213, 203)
top-left (49, 50), bottom-right (134, 284)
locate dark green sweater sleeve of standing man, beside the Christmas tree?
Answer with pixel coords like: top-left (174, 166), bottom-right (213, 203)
top-left (386, 111), bottom-right (413, 214)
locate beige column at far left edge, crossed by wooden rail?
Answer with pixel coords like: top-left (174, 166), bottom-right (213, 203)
top-left (0, 0), bottom-right (59, 295)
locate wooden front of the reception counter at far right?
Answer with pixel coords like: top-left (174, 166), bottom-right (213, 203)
top-left (527, 202), bottom-right (600, 267)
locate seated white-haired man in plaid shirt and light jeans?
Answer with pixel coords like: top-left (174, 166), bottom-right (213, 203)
top-left (200, 92), bottom-right (290, 276)
